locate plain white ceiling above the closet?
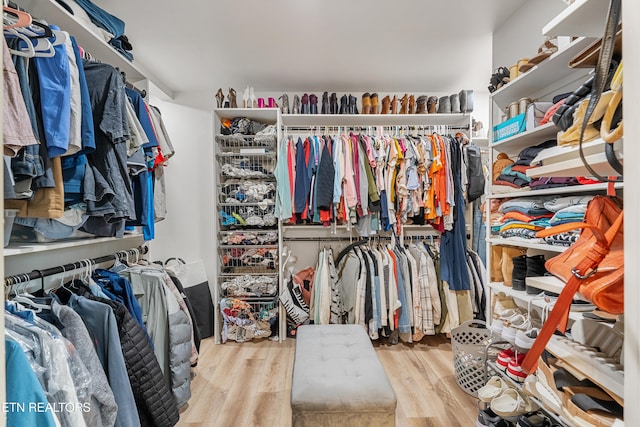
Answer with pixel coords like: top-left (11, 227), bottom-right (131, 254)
top-left (95, 0), bottom-right (525, 92)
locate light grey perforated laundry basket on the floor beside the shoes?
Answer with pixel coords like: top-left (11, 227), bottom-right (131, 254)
top-left (451, 320), bottom-right (492, 397)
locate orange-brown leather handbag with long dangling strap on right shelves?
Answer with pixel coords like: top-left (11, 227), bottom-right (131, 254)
top-left (522, 196), bottom-right (624, 373)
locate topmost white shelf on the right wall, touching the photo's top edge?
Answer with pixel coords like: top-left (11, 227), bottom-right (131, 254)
top-left (542, 0), bottom-right (609, 37)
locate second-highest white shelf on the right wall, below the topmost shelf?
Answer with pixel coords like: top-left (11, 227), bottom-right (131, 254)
top-left (491, 37), bottom-right (593, 110)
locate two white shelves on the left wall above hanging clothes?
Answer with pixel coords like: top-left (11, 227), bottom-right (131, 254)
top-left (2, 0), bottom-right (173, 275)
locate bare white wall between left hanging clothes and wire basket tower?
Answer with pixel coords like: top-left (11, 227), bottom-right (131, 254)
top-left (150, 96), bottom-right (216, 286)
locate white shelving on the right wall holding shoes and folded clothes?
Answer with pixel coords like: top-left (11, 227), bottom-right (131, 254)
top-left (486, 0), bottom-right (624, 418)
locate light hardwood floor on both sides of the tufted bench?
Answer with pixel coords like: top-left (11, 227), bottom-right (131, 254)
top-left (178, 336), bottom-right (477, 427)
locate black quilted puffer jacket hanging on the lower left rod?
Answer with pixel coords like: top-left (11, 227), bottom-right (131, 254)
top-left (83, 291), bottom-right (180, 427)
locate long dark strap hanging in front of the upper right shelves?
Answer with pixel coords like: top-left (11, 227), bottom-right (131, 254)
top-left (578, 0), bottom-right (622, 182)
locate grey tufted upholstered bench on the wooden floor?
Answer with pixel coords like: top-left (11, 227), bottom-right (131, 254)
top-left (291, 325), bottom-right (396, 427)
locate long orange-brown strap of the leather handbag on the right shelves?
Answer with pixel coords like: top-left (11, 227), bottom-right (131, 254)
top-left (521, 211), bottom-right (624, 374)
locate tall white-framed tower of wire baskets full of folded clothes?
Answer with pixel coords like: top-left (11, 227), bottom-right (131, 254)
top-left (213, 108), bottom-right (286, 344)
